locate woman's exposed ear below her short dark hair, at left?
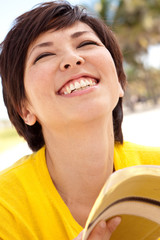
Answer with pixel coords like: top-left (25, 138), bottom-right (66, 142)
top-left (20, 103), bottom-right (37, 126)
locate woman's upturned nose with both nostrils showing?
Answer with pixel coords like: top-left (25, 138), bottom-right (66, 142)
top-left (60, 53), bottom-right (85, 71)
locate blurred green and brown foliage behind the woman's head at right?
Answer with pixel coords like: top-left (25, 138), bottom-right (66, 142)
top-left (89, 0), bottom-right (160, 110)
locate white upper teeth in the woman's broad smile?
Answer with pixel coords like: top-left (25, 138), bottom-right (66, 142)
top-left (64, 79), bottom-right (96, 94)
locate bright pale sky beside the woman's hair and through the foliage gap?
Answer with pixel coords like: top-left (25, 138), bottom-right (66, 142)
top-left (0, 0), bottom-right (160, 120)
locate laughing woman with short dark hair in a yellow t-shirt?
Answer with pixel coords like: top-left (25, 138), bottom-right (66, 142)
top-left (0, 1), bottom-right (160, 240)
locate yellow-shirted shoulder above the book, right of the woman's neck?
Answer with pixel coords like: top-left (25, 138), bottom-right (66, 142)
top-left (114, 142), bottom-right (160, 169)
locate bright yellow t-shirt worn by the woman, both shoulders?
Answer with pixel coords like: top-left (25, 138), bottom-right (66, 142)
top-left (0, 143), bottom-right (160, 240)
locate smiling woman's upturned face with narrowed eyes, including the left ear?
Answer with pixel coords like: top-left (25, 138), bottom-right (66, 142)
top-left (22, 22), bottom-right (123, 129)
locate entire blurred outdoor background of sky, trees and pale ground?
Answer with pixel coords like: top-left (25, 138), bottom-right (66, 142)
top-left (0, 0), bottom-right (160, 170)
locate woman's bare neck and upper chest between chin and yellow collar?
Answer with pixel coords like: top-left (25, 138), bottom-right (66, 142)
top-left (44, 116), bottom-right (114, 224)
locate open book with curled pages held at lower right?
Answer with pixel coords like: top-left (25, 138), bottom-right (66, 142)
top-left (83, 165), bottom-right (160, 240)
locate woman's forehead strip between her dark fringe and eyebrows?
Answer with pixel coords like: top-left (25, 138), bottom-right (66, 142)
top-left (29, 21), bottom-right (96, 50)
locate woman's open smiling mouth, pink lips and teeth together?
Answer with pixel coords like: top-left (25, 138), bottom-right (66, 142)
top-left (58, 76), bottom-right (99, 95)
